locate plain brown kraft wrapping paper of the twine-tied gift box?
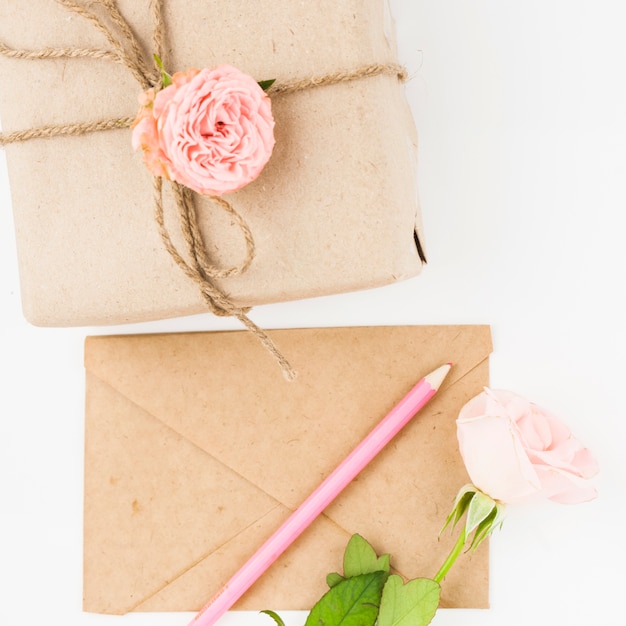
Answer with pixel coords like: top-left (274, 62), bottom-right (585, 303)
top-left (0, 0), bottom-right (422, 326)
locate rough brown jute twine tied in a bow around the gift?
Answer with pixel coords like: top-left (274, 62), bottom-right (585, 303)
top-left (0, 0), bottom-right (406, 380)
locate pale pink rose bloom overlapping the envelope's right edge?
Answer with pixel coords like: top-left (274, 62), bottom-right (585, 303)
top-left (457, 388), bottom-right (598, 504)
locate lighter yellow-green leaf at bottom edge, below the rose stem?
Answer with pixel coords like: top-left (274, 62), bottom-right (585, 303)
top-left (378, 574), bottom-right (441, 626)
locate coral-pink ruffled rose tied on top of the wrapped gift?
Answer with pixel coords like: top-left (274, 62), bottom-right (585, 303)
top-left (132, 65), bottom-right (274, 195)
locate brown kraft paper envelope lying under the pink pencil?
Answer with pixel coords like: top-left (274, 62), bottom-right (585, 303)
top-left (84, 326), bottom-right (491, 613)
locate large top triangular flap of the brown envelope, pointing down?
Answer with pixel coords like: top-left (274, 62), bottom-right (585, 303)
top-left (85, 326), bottom-right (491, 508)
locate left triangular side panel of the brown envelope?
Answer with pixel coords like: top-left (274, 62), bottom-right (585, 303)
top-left (83, 373), bottom-right (284, 613)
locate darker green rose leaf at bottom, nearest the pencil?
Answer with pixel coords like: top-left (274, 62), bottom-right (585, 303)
top-left (305, 572), bottom-right (388, 626)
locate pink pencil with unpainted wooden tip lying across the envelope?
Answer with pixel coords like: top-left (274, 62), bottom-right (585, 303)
top-left (189, 363), bottom-right (451, 626)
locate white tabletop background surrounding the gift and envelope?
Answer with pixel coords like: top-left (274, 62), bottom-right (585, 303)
top-left (0, 0), bottom-right (626, 626)
